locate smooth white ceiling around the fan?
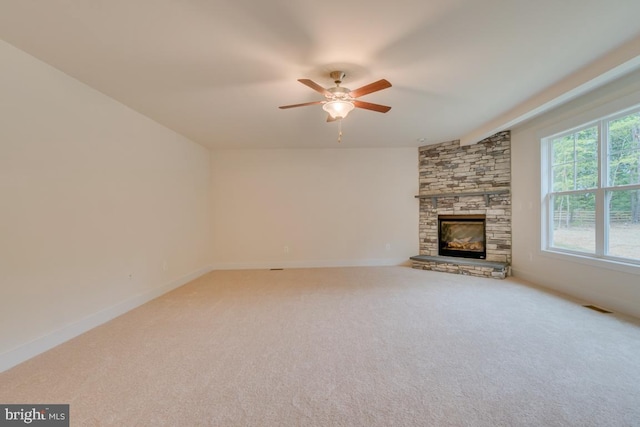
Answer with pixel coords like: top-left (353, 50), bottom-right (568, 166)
top-left (0, 0), bottom-right (640, 148)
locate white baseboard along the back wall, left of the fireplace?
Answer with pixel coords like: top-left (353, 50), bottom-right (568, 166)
top-left (213, 257), bottom-right (411, 270)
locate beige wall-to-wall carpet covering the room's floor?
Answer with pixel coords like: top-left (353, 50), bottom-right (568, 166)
top-left (0, 267), bottom-right (640, 426)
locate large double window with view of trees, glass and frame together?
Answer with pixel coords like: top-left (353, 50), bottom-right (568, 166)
top-left (542, 106), bottom-right (640, 264)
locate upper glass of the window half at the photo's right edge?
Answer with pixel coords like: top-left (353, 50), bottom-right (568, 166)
top-left (608, 112), bottom-right (640, 187)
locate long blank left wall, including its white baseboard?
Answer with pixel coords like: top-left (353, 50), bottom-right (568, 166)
top-left (0, 41), bottom-right (211, 371)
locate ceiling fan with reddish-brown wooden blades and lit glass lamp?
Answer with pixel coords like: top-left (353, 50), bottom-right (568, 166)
top-left (280, 71), bottom-right (391, 122)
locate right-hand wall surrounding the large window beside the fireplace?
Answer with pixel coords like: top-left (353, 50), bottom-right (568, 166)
top-left (511, 68), bottom-right (640, 317)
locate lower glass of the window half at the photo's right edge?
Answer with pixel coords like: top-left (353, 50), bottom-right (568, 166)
top-left (607, 190), bottom-right (640, 259)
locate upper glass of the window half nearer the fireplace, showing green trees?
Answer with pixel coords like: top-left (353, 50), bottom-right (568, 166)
top-left (551, 126), bottom-right (598, 191)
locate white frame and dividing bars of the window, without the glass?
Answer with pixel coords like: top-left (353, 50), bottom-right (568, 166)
top-left (540, 104), bottom-right (640, 273)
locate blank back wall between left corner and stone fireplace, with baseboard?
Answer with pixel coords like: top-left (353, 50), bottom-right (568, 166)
top-left (212, 147), bottom-right (418, 268)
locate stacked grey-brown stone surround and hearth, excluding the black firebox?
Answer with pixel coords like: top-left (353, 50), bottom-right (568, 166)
top-left (413, 131), bottom-right (511, 278)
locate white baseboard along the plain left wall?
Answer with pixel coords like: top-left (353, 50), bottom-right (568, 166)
top-left (0, 266), bottom-right (212, 372)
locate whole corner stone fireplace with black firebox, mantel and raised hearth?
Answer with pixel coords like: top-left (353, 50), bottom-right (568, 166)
top-left (411, 131), bottom-right (511, 278)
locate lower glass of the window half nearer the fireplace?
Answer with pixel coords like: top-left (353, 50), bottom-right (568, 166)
top-left (551, 193), bottom-right (596, 253)
